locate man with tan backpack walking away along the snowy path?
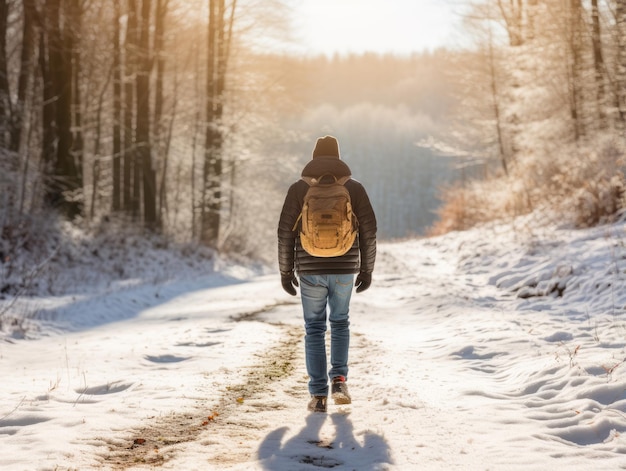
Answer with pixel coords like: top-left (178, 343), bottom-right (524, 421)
top-left (278, 136), bottom-right (376, 412)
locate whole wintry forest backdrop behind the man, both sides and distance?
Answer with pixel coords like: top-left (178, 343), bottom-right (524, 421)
top-left (0, 0), bottom-right (626, 292)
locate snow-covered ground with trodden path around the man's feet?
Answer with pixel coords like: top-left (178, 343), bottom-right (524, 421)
top-left (0, 219), bottom-right (626, 470)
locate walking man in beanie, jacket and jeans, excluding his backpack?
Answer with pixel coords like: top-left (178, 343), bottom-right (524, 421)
top-left (278, 136), bottom-right (376, 412)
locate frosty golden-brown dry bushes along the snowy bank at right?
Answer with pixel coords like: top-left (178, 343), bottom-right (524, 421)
top-left (428, 139), bottom-right (626, 236)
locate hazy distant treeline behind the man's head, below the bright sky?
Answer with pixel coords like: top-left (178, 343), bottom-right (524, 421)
top-left (260, 50), bottom-right (461, 239)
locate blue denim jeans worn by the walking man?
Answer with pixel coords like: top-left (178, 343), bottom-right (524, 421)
top-left (300, 275), bottom-right (354, 396)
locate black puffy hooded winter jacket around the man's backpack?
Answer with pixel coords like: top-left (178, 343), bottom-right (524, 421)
top-left (278, 157), bottom-right (376, 275)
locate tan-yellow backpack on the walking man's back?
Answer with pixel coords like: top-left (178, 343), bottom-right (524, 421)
top-left (293, 174), bottom-right (358, 257)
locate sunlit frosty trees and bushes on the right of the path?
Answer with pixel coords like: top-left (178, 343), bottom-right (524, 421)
top-left (431, 0), bottom-right (626, 233)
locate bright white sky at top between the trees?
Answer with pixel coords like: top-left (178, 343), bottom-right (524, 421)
top-left (293, 0), bottom-right (460, 56)
